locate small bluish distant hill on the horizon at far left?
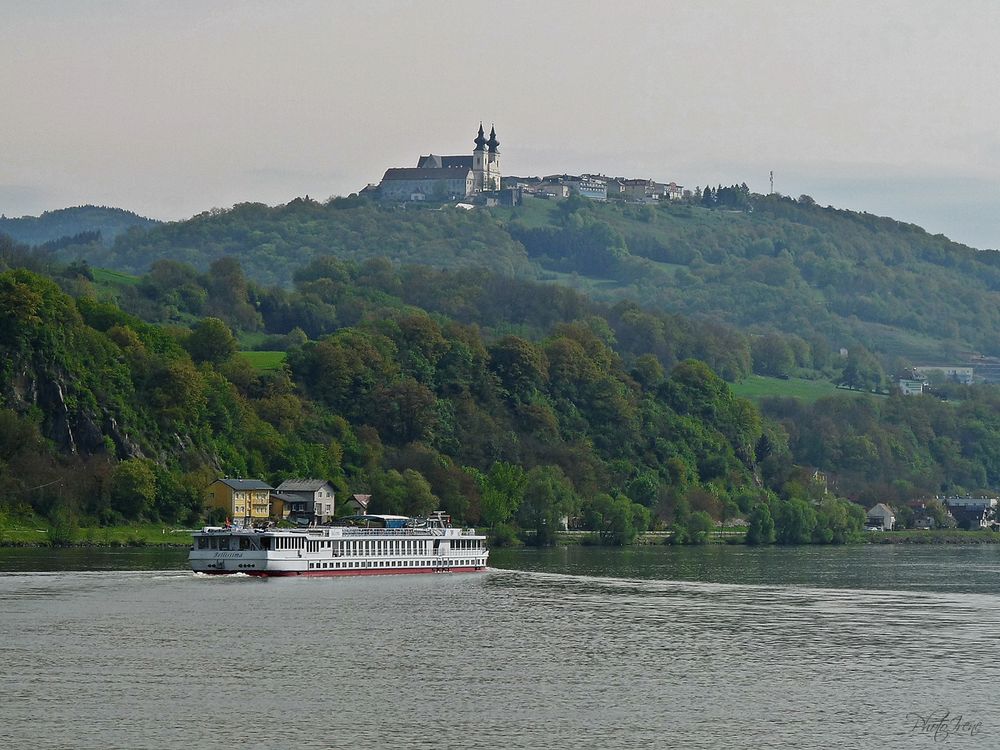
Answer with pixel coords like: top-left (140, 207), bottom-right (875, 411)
top-left (0, 206), bottom-right (160, 246)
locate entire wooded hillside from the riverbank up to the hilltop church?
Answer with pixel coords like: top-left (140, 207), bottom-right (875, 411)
top-left (0, 187), bottom-right (1000, 543)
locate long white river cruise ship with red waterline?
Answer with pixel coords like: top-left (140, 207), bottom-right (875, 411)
top-left (188, 513), bottom-right (489, 576)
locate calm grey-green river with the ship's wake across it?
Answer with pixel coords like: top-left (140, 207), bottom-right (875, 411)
top-left (0, 546), bottom-right (1000, 750)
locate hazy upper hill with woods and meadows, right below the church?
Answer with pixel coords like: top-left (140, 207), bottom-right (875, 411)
top-left (60, 195), bottom-right (1000, 362)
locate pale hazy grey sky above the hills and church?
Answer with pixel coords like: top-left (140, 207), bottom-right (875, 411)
top-left (0, 0), bottom-right (1000, 247)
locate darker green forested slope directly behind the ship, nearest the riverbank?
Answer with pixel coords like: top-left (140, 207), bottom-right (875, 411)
top-left (0, 241), bottom-right (880, 543)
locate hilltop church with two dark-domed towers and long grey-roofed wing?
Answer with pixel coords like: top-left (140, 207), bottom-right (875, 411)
top-left (379, 123), bottom-right (500, 201)
